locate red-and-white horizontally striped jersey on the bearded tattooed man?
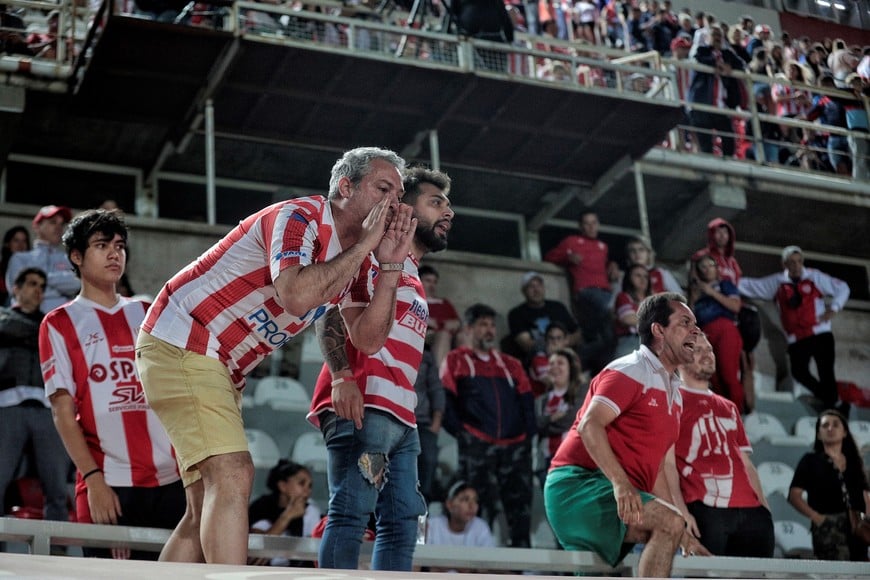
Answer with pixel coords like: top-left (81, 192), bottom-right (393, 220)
top-left (308, 256), bottom-right (429, 427)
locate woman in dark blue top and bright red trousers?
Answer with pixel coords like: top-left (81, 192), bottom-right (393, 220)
top-left (689, 254), bottom-right (746, 414)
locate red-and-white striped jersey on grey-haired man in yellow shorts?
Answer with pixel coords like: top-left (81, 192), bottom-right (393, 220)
top-left (142, 196), bottom-right (370, 389)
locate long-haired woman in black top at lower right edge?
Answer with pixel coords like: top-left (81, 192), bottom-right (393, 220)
top-left (788, 409), bottom-right (870, 562)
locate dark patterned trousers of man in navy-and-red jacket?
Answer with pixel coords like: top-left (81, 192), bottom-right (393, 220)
top-left (457, 432), bottom-right (532, 548)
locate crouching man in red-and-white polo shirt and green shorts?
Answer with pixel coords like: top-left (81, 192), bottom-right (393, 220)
top-left (544, 293), bottom-right (709, 577)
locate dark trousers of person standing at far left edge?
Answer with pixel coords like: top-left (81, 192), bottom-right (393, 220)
top-left (0, 403), bottom-right (70, 521)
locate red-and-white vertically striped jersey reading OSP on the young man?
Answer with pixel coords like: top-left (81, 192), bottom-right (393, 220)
top-left (39, 296), bottom-right (180, 487)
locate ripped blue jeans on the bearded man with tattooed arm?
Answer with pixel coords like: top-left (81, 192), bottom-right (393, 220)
top-left (319, 408), bottom-right (426, 571)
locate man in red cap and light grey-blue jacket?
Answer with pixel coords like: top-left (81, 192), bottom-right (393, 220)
top-left (6, 205), bottom-right (80, 314)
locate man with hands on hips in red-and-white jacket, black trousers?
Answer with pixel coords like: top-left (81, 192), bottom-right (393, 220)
top-left (738, 246), bottom-right (849, 416)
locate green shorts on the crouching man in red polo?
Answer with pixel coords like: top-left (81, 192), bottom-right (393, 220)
top-left (544, 465), bottom-right (655, 566)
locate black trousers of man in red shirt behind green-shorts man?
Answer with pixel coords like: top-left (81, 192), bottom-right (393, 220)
top-left (687, 501), bottom-right (774, 558)
